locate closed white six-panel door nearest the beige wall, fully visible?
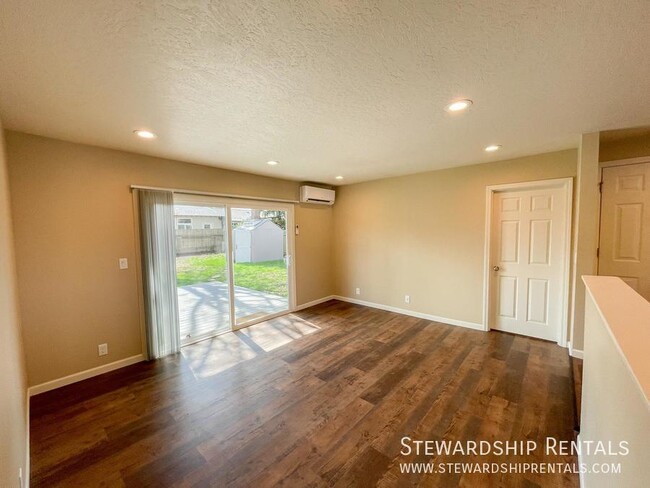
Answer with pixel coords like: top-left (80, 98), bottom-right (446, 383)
top-left (489, 182), bottom-right (568, 342)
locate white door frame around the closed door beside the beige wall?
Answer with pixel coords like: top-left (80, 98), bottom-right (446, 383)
top-left (483, 178), bottom-right (573, 347)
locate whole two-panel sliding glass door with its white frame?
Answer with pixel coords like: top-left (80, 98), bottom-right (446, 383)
top-left (174, 195), bottom-right (293, 344)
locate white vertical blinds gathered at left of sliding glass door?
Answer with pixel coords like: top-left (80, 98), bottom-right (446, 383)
top-left (138, 190), bottom-right (181, 359)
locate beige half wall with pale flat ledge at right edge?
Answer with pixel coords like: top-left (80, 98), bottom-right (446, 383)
top-left (578, 276), bottom-right (650, 488)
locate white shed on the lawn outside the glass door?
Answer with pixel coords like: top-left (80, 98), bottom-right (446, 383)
top-left (232, 219), bottom-right (284, 263)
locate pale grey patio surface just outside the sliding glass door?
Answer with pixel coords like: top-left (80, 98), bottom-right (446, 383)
top-left (177, 282), bottom-right (289, 343)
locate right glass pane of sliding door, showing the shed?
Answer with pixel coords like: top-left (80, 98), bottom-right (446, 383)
top-left (230, 208), bottom-right (289, 325)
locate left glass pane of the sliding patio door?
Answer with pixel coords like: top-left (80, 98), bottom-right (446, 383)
top-left (174, 202), bottom-right (231, 344)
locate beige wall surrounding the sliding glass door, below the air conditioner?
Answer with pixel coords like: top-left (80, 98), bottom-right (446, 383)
top-left (6, 131), bottom-right (333, 385)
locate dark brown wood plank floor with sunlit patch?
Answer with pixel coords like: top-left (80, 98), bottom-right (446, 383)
top-left (31, 301), bottom-right (578, 488)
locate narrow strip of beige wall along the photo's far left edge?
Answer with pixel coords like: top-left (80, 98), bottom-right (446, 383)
top-left (0, 126), bottom-right (28, 486)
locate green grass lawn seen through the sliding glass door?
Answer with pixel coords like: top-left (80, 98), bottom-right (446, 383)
top-left (176, 254), bottom-right (288, 297)
